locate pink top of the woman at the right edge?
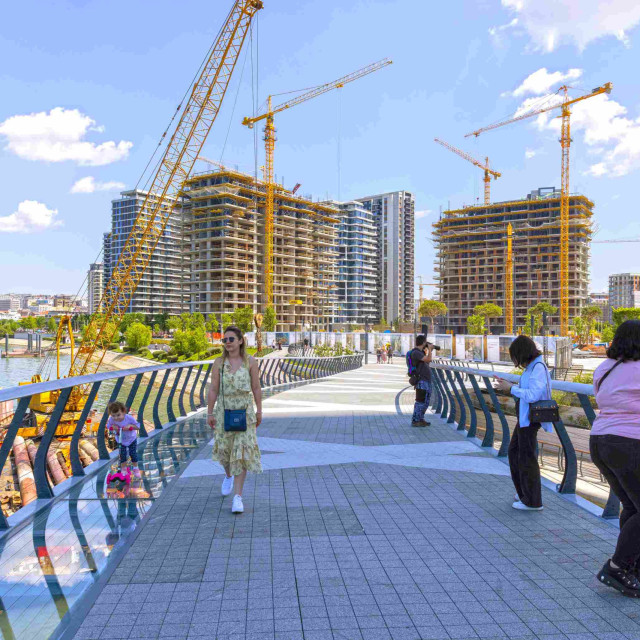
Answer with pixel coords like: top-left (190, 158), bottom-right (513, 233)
top-left (591, 358), bottom-right (640, 440)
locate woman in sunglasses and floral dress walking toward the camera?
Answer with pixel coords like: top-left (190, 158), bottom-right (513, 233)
top-left (207, 327), bottom-right (262, 513)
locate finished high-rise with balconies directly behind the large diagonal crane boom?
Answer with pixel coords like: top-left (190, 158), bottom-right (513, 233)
top-left (103, 190), bottom-right (188, 315)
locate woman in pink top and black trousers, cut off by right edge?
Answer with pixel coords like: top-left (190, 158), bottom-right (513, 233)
top-left (589, 320), bottom-right (640, 598)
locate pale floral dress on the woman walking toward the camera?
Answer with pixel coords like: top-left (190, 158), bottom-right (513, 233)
top-left (212, 362), bottom-right (262, 476)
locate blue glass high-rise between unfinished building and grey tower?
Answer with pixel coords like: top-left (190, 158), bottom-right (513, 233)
top-left (330, 201), bottom-right (380, 325)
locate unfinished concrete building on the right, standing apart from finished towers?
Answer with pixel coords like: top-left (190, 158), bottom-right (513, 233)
top-left (434, 188), bottom-right (593, 332)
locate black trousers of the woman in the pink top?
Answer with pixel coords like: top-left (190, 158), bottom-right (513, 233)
top-left (589, 435), bottom-right (640, 569)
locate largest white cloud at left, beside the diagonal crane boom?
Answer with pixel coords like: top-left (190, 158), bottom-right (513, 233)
top-left (0, 107), bottom-right (133, 166)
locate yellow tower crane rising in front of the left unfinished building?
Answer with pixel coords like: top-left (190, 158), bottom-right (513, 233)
top-left (242, 58), bottom-right (391, 306)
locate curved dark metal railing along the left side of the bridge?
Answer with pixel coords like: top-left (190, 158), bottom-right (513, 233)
top-left (0, 354), bottom-right (362, 530)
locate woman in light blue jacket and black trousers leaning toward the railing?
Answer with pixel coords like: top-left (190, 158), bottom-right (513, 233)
top-left (498, 336), bottom-right (553, 511)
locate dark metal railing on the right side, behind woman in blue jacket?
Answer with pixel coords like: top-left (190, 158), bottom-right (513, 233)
top-left (431, 361), bottom-right (620, 518)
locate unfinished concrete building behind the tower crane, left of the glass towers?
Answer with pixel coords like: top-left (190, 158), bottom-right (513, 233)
top-left (183, 169), bottom-right (340, 331)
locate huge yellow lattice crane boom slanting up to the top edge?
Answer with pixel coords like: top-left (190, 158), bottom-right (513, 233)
top-left (69, 0), bottom-right (263, 376)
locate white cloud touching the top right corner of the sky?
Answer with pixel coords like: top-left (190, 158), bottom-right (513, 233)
top-left (496, 0), bottom-right (640, 52)
